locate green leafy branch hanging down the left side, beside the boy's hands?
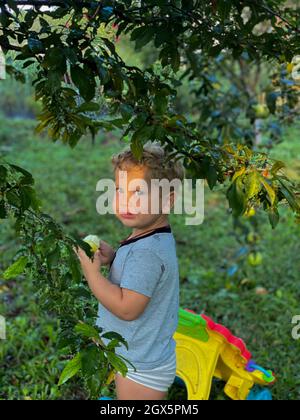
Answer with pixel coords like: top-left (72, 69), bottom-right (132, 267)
top-left (0, 163), bottom-right (131, 398)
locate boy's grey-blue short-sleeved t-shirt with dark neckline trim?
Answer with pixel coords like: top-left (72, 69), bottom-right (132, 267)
top-left (97, 226), bottom-right (179, 369)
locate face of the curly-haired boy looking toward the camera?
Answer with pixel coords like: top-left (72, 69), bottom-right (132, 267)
top-left (113, 166), bottom-right (173, 228)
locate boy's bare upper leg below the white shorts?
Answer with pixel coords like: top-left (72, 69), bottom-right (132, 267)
top-left (115, 373), bottom-right (167, 400)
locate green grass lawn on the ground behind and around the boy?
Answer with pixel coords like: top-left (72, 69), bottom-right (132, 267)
top-left (0, 120), bottom-right (300, 400)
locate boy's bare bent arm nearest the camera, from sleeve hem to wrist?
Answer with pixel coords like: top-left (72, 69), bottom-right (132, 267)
top-left (86, 273), bottom-right (150, 321)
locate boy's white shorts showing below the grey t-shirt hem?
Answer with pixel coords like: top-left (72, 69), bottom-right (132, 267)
top-left (121, 352), bottom-right (176, 392)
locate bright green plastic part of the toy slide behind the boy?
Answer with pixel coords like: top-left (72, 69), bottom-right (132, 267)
top-left (177, 308), bottom-right (209, 343)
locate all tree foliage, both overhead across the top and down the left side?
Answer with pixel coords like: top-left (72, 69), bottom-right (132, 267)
top-left (0, 0), bottom-right (300, 396)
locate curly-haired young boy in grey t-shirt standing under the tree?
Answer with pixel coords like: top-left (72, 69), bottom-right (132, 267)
top-left (77, 142), bottom-right (184, 400)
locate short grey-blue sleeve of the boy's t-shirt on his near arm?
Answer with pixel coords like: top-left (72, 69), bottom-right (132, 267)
top-left (120, 249), bottom-right (165, 297)
